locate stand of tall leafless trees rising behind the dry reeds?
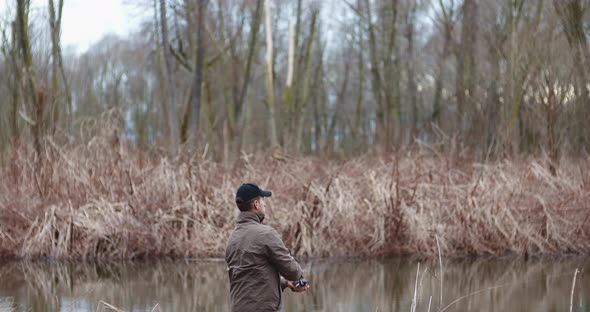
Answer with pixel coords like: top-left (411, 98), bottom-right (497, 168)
top-left (0, 0), bottom-right (590, 159)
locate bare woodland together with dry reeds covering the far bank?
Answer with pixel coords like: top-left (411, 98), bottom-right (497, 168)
top-left (0, 0), bottom-right (590, 258)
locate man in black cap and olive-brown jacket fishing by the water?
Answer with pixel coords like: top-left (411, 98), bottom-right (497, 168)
top-left (225, 183), bottom-right (309, 312)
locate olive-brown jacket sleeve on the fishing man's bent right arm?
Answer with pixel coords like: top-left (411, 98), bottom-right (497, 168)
top-left (266, 229), bottom-right (303, 281)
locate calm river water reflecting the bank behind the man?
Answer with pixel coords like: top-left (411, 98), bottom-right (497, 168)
top-left (0, 258), bottom-right (590, 312)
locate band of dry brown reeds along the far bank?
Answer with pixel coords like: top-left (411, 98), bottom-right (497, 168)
top-left (0, 125), bottom-right (590, 259)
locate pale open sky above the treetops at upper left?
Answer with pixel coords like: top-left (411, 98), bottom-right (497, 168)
top-left (0, 0), bottom-right (140, 53)
